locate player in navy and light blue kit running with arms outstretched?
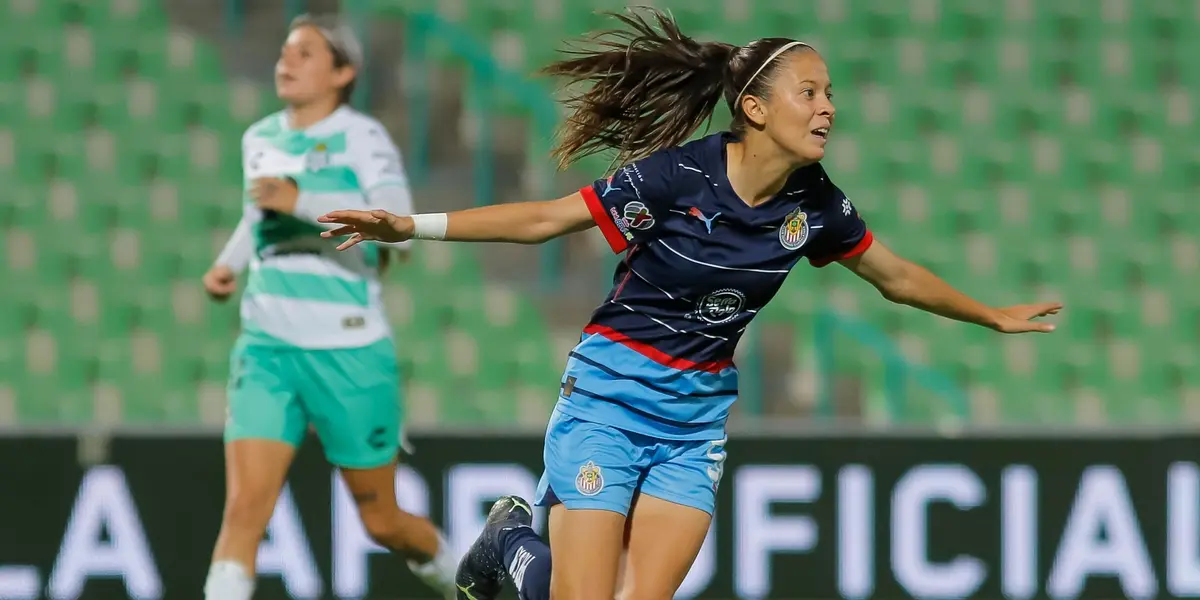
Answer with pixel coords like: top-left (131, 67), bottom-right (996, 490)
top-left (320, 8), bottom-right (1060, 600)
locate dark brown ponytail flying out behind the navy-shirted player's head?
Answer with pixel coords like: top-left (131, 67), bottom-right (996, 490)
top-left (542, 8), bottom-right (738, 168)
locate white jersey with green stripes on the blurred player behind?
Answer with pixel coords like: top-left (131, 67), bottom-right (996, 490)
top-left (217, 106), bottom-right (412, 349)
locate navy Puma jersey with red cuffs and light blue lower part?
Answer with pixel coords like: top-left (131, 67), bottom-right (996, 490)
top-left (559, 133), bottom-right (872, 439)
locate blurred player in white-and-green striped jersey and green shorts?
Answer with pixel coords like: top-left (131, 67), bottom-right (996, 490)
top-left (204, 17), bottom-right (457, 600)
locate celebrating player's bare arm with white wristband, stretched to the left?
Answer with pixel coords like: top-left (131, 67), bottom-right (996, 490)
top-left (318, 192), bottom-right (595, 250)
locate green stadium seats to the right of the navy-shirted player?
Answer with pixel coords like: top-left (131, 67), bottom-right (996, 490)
top-left (698, 0), bottom-right (1200, 422)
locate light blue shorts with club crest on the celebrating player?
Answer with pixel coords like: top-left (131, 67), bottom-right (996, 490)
top-left (534, 409), bottom-right (725, 515)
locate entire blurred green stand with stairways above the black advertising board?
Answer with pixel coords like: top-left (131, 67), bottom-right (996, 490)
top-left (0, 0), bottom-right (1200, 428)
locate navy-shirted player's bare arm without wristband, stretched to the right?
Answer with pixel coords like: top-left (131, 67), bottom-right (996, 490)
top-left (842, 240), bottom-right (1062, 334)
